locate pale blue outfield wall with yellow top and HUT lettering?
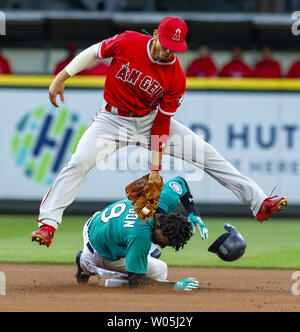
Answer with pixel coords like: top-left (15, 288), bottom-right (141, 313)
top-left (0, 75), bottom-right (300, 215)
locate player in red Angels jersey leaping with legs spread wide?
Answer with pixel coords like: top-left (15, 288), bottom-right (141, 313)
top-left (31, 17), bottom-right (287, 246)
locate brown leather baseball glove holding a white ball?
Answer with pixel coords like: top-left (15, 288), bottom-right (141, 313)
top-left (125, 174), bottom-right (164, 225)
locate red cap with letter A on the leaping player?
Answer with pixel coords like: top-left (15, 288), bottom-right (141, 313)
top-left (158, 17), bottom-right (188, 52)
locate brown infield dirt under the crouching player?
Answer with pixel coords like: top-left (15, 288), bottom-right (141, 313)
top-left (0, 264), bottom-right (300, 312)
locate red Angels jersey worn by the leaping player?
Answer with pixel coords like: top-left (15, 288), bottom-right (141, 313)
top-left (98, 31), bottom-right (186, 116)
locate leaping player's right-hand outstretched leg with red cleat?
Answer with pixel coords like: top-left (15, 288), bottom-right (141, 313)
top-left (166, 119), bottom-right (287, 222)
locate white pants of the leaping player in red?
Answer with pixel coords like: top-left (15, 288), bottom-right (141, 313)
top-left (39, 102), bottom-right (267, 228)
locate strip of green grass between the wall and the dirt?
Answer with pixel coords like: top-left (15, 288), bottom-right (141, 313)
top-left (0, 216), bottom-right (300, 270)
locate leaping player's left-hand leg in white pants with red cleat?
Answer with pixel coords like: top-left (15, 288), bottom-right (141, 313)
top-left (31, 122), bottom-right (119, 247)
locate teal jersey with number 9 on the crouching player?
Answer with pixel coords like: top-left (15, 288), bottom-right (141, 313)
top-left (89, 178), bottom-right (190, 274)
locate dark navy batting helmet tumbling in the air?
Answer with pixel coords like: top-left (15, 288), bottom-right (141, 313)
top-left (208, 224), bottom-right (247, 262)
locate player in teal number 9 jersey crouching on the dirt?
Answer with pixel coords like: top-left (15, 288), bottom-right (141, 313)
top-left (76, 177), bottom-right (208, 290)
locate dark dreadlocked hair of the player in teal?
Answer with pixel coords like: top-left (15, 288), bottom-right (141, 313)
top-left (159, 214), bottom-right (193, 251)
